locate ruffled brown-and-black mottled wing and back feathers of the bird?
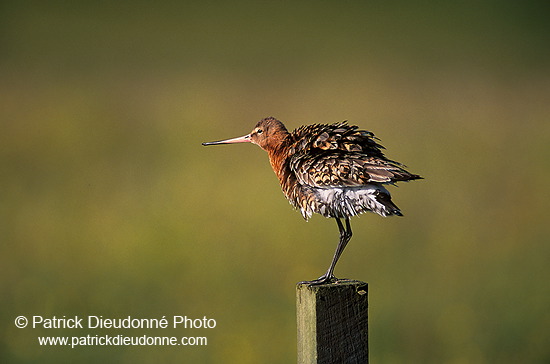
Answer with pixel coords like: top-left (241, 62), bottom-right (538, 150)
top-left (289, 122), bottom-right (420, 187)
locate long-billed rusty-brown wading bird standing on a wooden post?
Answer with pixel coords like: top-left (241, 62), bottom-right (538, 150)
top-left (202, 117), bottom-right (422, 285)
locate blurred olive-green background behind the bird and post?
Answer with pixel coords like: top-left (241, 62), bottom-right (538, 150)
top-left (0, 0), bottom-right (550, 363)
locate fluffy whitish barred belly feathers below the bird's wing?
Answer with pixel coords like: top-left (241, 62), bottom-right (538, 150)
top-left (300, 184), bottom-right (399, 218)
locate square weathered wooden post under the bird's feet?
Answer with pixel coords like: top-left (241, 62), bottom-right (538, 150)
top-left (296, 280), bottom-right (369, 364)
